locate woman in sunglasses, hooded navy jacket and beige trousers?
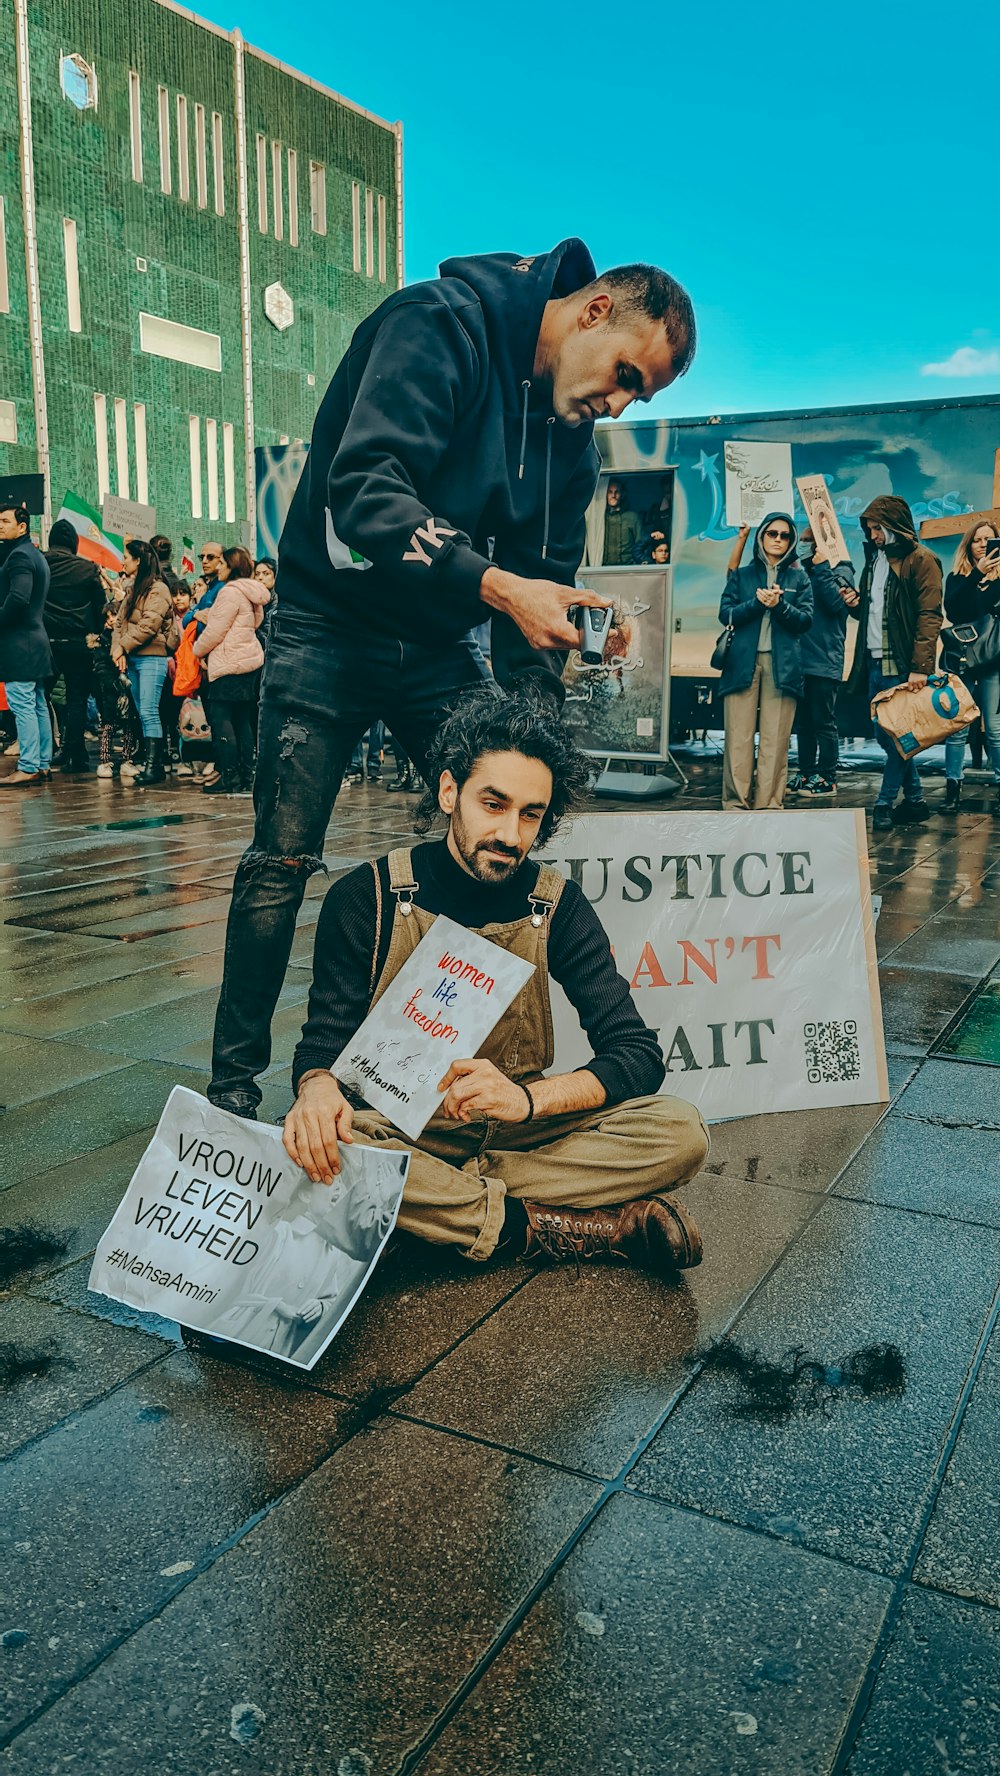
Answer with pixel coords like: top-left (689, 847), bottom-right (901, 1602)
top-left (718, 511), bottom-right (813, 810)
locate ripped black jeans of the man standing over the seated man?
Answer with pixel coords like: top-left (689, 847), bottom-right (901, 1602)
top-left (208, 610), bottom-right (488, 1110)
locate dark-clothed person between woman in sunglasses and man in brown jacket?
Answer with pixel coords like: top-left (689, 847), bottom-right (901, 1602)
top-left (789, 527), bottom-right (858, 801)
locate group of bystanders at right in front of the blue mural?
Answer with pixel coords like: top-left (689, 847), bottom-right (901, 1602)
top-left (714, 494), bottom-right (1000, 833)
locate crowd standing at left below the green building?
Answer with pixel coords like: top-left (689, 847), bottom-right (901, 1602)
top-left (0, 506), bottom-right (423, 796)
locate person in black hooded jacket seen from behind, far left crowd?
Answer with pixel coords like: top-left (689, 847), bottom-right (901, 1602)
top-left (44, 519), bottom-right (105, 771)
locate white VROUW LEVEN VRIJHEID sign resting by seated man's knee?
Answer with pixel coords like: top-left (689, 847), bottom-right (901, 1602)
top-left (89, 1085), bottom-right (410, 1369)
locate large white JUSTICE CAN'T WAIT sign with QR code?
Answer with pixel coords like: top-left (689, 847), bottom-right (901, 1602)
top-left (547, 810), bottom-right (888, 1121)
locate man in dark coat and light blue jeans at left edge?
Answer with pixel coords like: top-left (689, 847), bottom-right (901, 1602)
top-left (0, 506), bottom-right (52, 790)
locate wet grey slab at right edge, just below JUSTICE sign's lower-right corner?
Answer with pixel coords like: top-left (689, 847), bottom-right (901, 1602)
top-left (837, 1115), bottom-right (1000, 1227)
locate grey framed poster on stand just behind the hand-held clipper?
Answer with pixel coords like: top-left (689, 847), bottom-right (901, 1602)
top-left (563, 567), bottom-right (673, 760)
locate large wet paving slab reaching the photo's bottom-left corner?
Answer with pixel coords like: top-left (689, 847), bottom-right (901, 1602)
top-left (0, 1396), bottom-right (597, 1776)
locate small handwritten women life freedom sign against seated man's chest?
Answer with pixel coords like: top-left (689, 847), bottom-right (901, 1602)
top-left (330, 916), bottom-right (535, 1140)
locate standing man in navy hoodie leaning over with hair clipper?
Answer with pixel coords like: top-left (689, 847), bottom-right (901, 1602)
top-left (210, 240), bottom-right (694, 1115)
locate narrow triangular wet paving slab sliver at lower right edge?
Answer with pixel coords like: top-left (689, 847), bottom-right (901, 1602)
top-left (915, 1328), bottom-right (1000, 1612)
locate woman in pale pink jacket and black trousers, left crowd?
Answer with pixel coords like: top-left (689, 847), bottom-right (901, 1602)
top-left (194, 547), bottom-right (270, 796)
